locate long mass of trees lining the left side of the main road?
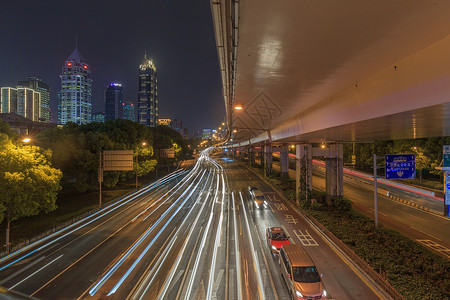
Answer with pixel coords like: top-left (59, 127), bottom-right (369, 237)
top-left (0, 119), bottom-right (192, 252)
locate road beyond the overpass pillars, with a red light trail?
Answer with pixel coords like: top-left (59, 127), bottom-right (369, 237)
top-left (273, 157), bottom-right (450, 258)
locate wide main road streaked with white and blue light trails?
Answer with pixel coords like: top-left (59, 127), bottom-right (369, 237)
top-left (0, 152), bottom-right (385, 299)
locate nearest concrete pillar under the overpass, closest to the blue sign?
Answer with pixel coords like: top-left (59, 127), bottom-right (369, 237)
top-left (325, 143), bottom-right (344, 205)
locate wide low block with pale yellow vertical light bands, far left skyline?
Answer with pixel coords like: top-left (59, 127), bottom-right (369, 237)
top-left (1, 87), bottom-right (41, 122)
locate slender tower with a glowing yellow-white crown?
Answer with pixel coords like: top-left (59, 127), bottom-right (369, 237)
top-left (138, 55), bottom-right (158, 126)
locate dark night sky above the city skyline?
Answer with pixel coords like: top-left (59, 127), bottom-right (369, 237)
top-left (0, 0), bottom-right (225, 132)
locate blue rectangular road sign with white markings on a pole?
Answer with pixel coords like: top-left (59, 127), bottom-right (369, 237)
top-left (384, 154), bottom-right (416, 179)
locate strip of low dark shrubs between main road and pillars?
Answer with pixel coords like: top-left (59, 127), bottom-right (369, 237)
top-left (259, 169), bottom-right (450, 300)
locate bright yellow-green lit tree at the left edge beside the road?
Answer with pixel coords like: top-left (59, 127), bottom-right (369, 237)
top-left (0, 133), bottom-right (62, 252)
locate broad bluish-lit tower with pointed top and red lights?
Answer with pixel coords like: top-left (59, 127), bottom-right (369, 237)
top-left (58, 48), bottom-right (92, 124)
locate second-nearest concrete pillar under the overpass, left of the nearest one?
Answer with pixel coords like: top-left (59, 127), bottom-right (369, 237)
top-left (295, 144), bottom-right (312, 202)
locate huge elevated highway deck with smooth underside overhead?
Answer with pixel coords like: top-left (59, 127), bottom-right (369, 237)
top-left (211, 0), bottom-right (450, 145)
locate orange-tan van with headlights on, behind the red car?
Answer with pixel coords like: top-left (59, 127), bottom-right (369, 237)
top-left (279, 244), bottom-right (327, 300)
